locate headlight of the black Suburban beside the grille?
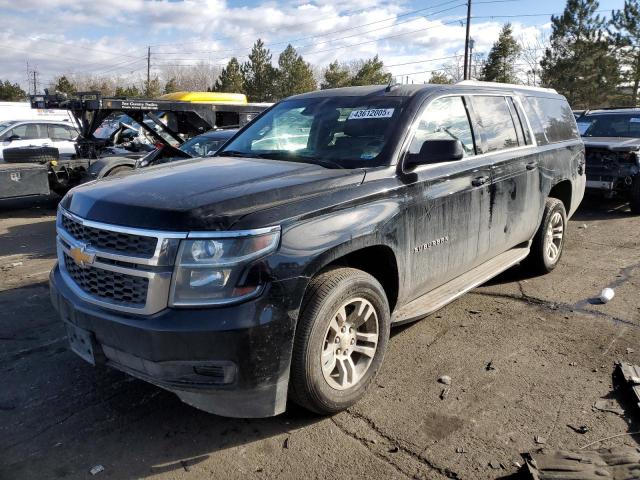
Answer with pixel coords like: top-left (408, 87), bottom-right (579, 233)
top-left (169, 227), bottom-right (280, 307)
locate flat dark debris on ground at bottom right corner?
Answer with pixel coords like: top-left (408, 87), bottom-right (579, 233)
top-left (523, 447), bottom-right (640, 480)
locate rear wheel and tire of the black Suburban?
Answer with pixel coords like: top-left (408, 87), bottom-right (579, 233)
top-left (523, 198), bottom-right (567, 274)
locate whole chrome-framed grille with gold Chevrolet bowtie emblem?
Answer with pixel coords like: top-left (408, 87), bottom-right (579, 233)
top-left (56, 208), bottom-right (187, 315)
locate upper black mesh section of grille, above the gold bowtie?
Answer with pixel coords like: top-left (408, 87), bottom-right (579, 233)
top-left (61, 215), bottom-right (158, 257)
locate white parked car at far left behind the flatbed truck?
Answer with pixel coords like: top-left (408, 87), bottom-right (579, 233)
top-left (0, 120), bottom-right (78, 159)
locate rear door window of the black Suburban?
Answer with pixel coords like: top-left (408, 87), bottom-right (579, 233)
top-left (471, 95), bottom-right (519, 153)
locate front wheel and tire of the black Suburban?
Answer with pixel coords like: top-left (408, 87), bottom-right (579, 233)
top-left (289, 268), bottom-right (391, 415)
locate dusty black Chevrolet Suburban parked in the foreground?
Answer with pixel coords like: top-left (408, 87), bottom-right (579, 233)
top-left (50, 82), bottom-right (585, 417)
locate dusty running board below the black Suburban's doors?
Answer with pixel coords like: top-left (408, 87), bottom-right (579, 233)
top-left (391, 247), bottom-right (529, 325)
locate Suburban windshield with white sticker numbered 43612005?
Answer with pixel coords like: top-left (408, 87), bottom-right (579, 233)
top-left (218, 97), bottom-right (403, 168)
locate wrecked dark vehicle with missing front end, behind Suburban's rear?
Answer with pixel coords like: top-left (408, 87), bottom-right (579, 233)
top-left (578, 108), bottom-right (640, 213)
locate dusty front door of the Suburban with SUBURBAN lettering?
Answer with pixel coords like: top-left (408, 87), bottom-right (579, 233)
top-left (404, 96), bottom-right (491, 298)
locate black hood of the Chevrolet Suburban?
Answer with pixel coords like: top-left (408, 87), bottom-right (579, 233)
top-left (62, 157), bottom-right (364, 231)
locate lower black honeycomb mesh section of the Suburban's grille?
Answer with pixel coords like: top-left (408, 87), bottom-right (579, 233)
top-left (63, 253), bottom-right (149, 307)
